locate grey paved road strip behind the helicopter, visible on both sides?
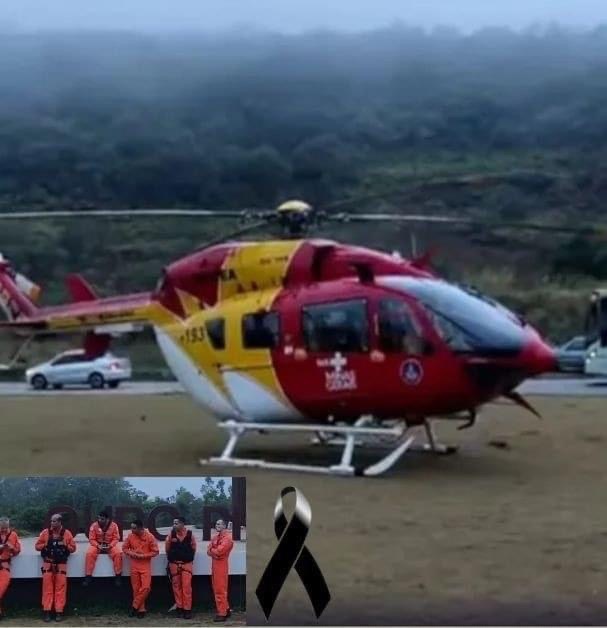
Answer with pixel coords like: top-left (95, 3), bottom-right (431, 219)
top-left (0, 377), bottom-right (607, 397)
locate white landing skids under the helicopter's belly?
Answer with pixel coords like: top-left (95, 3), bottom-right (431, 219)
top-left (200, 417), bottom-right (455, 477)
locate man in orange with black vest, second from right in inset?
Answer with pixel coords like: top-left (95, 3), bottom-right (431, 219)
top-left (164, 517), bottom-right (196, 619)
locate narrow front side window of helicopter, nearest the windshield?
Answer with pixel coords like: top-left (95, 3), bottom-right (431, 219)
top-left (377, 298), bottom-right (424, 355)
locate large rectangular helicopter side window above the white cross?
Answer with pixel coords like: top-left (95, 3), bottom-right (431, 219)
top-left (302, 300), bottom-right (369, 353)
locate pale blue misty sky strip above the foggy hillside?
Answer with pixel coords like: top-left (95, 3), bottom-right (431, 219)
top-left (0, 0), bottom-right (607, 32)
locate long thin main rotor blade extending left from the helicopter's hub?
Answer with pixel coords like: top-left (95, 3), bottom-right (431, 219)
top-left (0, 209), bottom-right (274, 220)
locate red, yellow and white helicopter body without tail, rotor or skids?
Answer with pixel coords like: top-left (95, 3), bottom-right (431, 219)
top-left (148, 241), bottom-right (554, 423)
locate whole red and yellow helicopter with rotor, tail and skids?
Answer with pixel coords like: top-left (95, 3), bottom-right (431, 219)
top-left (0, 191), bottom-right (600, 476)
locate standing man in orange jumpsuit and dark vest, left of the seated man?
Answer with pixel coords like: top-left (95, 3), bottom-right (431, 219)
top-left (35, 515), bottom-right (76, 622)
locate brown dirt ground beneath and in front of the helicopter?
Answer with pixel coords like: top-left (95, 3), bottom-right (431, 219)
top-left (0, 395), bottom-right (607, 625)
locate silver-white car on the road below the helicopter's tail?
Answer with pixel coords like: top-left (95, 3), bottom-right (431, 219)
top-left (25, 349), bottom-right (132, 390)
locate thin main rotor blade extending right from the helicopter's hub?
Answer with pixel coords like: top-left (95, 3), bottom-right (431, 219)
top-left (326, 213), bottom-right (607, 236)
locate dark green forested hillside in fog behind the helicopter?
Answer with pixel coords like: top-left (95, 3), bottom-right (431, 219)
top-left (0, 26), bottom-right (607, 356)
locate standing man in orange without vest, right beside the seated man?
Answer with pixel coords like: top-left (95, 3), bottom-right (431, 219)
top-left (122, 519), bottom-right (160, 617)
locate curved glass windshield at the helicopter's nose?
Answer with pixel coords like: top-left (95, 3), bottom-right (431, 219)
top-left (378, 277), bottom-right (525, 355)
